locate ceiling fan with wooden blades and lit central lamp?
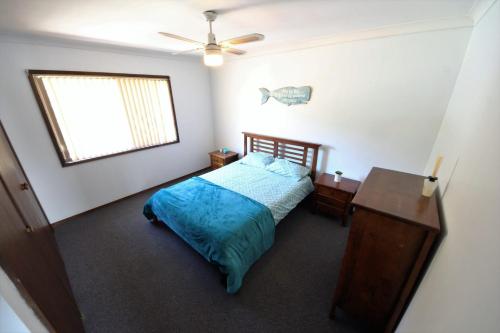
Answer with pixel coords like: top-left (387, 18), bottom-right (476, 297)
top-left (159, 10), bottom-right (264, 66)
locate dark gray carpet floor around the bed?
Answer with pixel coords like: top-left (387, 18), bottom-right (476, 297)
top-left (55, 182), bottom-right (363, 333)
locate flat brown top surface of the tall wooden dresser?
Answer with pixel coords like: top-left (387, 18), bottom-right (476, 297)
top-left (352, 167), bottom-right (440, 231)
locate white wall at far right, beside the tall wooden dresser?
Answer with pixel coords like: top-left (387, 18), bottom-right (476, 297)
top-left (398, 1), bottom-right (500, 333)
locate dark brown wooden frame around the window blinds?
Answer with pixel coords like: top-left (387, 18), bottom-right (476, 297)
top-left (27, 69), bottom-right (180, 168)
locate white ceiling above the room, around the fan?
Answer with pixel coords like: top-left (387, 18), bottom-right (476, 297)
top-left (0, 0), bottom-right (480, 55)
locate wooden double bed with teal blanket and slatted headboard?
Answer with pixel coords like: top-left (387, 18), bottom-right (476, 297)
top-left (144, 132), bottom-right (320, 294)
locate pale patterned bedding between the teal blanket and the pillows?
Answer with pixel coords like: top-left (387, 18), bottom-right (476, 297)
top-left (200, 161), bottom-right (314, 225)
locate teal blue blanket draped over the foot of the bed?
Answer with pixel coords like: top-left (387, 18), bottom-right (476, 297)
top-left (144, 177), bottom-right (275, 294)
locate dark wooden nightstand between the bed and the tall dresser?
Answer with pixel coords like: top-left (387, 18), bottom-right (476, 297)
top-left (313, 173), bottom-right (361, 226)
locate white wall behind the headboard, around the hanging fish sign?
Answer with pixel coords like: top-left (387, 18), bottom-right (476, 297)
top-left (212, 28), bottom-right (470, 179)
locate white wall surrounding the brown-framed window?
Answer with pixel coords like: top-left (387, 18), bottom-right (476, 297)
top-left (0, 40), bottom-right (214, 222)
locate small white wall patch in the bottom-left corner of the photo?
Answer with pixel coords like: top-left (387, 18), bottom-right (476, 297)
top-left (0, 267), bottom-right (48, 333)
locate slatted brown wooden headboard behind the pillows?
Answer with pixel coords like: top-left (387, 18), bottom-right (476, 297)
top-left (243, 132), bottom-right (321, 180)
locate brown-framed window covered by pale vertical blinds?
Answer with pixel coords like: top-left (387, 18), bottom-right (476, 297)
top-left (28, 70), bottom-right (179, 166)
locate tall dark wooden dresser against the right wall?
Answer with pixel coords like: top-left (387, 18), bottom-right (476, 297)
top-left (330, 168), bottom-right (440, 332)
